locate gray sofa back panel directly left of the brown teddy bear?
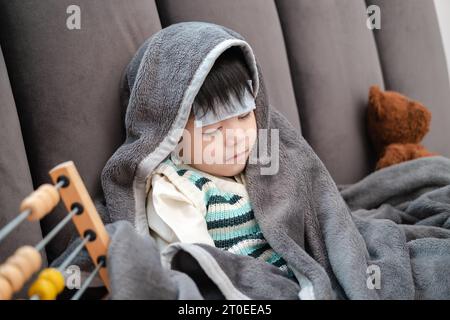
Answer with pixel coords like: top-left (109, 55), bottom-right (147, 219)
top-left (276, 0), bottom-right (383, 183)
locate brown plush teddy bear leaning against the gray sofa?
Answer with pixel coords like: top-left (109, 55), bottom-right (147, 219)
top-left (367, 86), bottom-right (437, 170)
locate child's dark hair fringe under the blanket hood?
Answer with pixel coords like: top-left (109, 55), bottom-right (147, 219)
top-left (194, 47), bottom-right (251, 116)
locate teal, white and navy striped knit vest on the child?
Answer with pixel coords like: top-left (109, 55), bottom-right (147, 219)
top-left (158, 159), bottom-right (293, 277)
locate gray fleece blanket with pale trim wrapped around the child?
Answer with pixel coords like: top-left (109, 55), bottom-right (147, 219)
top-left (51, 22), bottom-right (450, 299)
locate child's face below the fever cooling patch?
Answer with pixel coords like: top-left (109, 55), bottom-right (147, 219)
top-left (179, 111), bottom-right (257, 177)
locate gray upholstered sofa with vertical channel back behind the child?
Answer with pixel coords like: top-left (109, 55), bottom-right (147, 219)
top-left (0, 0), bottom-right (450, 272)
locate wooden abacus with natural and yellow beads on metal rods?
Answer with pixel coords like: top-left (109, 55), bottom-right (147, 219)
top-left (0, 161), bottom-right (109, 300)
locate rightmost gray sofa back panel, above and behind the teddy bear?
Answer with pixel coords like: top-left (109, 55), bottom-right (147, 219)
top-left (367, 0), bottom-right (450, 157)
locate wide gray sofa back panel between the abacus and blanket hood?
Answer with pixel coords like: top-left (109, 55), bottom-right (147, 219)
top-left (0, 0), bottom-right (161, 260)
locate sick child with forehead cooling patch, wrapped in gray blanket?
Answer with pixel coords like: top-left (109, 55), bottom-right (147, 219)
top-left (147, 47), bottom-right (288, 272)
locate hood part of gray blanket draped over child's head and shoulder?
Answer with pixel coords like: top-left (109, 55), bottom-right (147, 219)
top-left (102, 22), bottom-right (267, 234)
